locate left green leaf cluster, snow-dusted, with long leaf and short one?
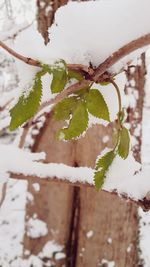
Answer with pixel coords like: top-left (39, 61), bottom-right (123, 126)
top-left (9, 60), bottom-right (84, 131)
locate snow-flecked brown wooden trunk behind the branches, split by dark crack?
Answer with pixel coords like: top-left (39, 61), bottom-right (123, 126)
top-left (24, 0), bottom-right (145, 267)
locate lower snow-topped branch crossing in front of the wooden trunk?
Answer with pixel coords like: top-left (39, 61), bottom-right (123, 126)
top-left (10, 159), bottom-right (150, 214)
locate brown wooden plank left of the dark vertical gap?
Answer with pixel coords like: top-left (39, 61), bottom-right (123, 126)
top-left (24, 113), bottom-right (74, 266)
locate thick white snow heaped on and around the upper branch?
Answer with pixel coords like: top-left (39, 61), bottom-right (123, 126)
top-left (12, 0), bottom-right (150, 88)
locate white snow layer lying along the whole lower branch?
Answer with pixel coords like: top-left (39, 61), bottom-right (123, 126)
top-left (0, 145), bottom-right (150, 199)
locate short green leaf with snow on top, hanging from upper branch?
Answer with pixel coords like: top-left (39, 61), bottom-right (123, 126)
top-left (51, 60), bottom-right (67, 94)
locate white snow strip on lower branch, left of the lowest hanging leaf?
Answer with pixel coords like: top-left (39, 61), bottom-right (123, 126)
top-left (0, 145), bottom-right (93, 184)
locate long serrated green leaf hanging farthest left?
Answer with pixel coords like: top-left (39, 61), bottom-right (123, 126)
top-left (9, 73), bottom-right (42, 131)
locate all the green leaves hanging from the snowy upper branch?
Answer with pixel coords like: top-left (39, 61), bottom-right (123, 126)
top-left (10, 60), bottom-right (130, 193)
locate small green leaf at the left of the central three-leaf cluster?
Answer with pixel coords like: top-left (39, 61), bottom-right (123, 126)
top-left (54, 96), bottom-right (77, 120)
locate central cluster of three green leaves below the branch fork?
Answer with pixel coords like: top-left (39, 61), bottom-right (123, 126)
top-left (54, 87), bottom-right (110, 140)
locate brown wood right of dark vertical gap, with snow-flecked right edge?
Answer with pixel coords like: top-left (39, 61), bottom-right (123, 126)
top-left (76, 55), bottom-right (146, 267)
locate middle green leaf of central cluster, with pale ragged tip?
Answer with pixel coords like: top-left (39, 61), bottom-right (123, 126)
top-left (59, 101), bottom-right (88, 140)
